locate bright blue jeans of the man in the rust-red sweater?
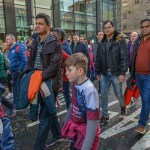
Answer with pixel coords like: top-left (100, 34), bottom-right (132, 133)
top-left (136, 74), bottom-right (150, 127)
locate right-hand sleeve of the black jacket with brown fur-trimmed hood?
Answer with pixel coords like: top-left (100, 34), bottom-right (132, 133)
top-left (120, 39), bottom-right (129, 75)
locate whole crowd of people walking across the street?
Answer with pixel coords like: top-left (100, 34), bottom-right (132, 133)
top-left (0, 13), bottom-right (150, 150)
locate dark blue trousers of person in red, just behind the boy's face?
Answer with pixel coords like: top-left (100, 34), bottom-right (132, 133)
top-left (62, 81), bottom-right (71, 110)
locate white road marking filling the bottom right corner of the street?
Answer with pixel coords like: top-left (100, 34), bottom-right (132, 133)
top-left (130, 131), bottom-right (150, 150)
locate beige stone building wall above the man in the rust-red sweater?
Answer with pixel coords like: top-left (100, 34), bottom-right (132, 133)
top-left (122, 0), bottom-right (150, 34)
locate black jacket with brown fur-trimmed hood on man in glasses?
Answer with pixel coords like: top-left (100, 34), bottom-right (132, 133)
top-left (95, 31), bottom-right (129, 75)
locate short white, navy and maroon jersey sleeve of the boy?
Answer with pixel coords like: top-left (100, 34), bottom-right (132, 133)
top-left (86, 87), bottom-right (99, 120)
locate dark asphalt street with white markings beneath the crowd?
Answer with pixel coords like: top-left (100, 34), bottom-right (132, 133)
top-left (8, 81), bottom-right (150, 150)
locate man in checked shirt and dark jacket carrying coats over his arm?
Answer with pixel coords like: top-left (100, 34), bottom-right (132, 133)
top-left (27, 13), bottom-right (62, 150)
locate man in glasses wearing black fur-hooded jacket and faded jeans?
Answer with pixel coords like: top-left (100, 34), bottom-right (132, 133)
top-left (95, 21), bottom-right (129, 125)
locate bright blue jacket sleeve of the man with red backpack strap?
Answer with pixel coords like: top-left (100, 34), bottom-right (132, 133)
top-left (18, 46), bottom-right (27, 71)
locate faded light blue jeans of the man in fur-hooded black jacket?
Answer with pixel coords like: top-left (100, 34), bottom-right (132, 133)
top-left (100, 72), bottom-right (124, 117)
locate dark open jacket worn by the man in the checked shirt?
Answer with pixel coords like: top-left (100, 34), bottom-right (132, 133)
top-left (27, 35), bottom-right (62, 91)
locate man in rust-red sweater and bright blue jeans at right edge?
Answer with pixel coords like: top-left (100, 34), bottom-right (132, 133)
top-left (131, 19), bottom-right (150, 134)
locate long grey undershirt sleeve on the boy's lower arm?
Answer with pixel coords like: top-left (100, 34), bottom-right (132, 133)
top-left (81, 120), bottom-right (99, 150)
